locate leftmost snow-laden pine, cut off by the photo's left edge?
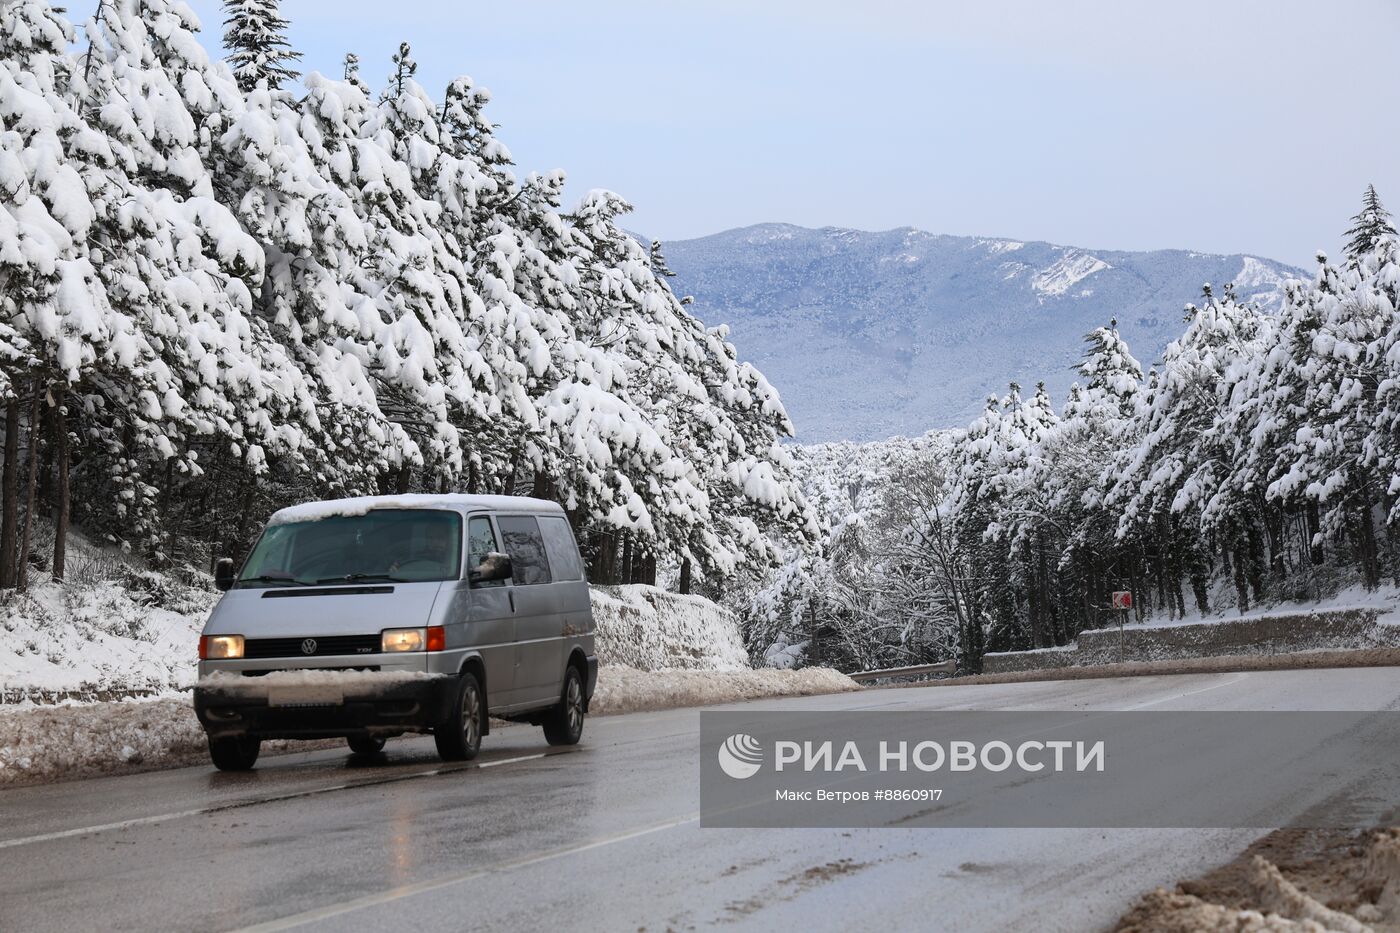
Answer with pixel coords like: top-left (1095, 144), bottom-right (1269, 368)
top-left (0, 0), bottom-right (93, 588)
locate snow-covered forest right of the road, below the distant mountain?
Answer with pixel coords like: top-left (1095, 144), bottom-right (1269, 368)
top-left (748, 188), bottom-right (1400, 671)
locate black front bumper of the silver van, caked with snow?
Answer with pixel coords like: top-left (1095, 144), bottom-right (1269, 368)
top-left (195, 675), bottom-right (456, 738)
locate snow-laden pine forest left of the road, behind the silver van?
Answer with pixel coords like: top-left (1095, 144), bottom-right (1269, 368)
top-left (0, 0), bottom-right (819, 591)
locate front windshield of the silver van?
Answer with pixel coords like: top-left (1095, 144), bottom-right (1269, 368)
top-left (238, 509), bottom-right (462, 587)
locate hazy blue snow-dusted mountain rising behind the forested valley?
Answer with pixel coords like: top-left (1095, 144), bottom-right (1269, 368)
top-left (665, 224), bottom-right (1306, 443)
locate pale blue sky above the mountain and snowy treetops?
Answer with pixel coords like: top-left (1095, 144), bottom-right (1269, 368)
top-left (190, 0), bottom-right (1400, 266)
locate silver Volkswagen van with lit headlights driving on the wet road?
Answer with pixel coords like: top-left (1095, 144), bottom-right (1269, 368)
top-left (195, 496), bottom-right (598, 770)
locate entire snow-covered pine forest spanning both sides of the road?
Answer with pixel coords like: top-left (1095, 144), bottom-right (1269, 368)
top-left (0, 0), bottom-right (1400, 683)
